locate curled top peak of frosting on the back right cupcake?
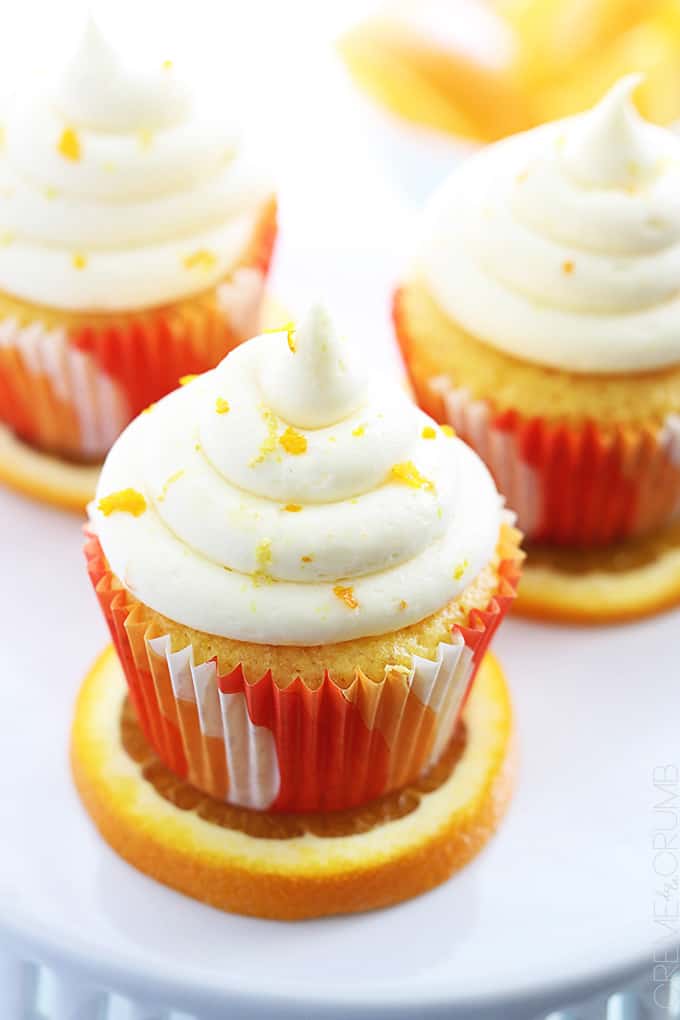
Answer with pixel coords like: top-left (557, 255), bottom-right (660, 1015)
top-left (564, 74), bottom-right (660, 189)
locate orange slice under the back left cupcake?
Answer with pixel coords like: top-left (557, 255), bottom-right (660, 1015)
top-left (0, 296), bottom-right (286, 513)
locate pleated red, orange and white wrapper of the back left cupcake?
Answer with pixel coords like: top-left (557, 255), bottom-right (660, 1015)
top-left (0, 201), bottom-right (276, 461)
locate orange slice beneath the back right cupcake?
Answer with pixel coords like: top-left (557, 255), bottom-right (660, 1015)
top-left (513, 523), bottom-right (680, 623)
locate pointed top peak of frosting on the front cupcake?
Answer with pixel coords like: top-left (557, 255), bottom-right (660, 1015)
top-left (262, 305), bottom-right (366, 428)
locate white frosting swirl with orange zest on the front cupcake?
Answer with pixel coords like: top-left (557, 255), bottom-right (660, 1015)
top-left (90, 309), bottom-right (501, 645)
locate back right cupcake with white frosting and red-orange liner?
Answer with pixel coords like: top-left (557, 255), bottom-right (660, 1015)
top-left (395, 77), bottom-right (680, 612)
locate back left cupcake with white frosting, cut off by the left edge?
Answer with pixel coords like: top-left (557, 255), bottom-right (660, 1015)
top-left (0, 20), bottom-right (276, 462)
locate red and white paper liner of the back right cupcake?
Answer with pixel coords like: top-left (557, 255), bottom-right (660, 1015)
top-left (428, 376), bottom-right (680, 546)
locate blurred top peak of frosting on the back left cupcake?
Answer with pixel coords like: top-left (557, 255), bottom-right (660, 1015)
top-left (55, 14), bottom-right (191, 132)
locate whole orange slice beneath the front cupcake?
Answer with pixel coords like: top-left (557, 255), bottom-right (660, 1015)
top-left (71, 647), bottom-right (514, 920)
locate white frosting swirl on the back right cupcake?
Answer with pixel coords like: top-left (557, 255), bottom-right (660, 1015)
top-left (417, 75), bottom-right (680, 372)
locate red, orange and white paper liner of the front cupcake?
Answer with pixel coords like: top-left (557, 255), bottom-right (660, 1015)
top-left (86, 531), bottom-right (519, 812)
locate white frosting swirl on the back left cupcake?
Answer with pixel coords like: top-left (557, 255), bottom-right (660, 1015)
top-left (0, 19), bottom-right (271, 311)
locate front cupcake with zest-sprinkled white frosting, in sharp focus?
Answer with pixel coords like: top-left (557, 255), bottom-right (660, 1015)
top-left (75, 308), bottom-right (520, 916)
